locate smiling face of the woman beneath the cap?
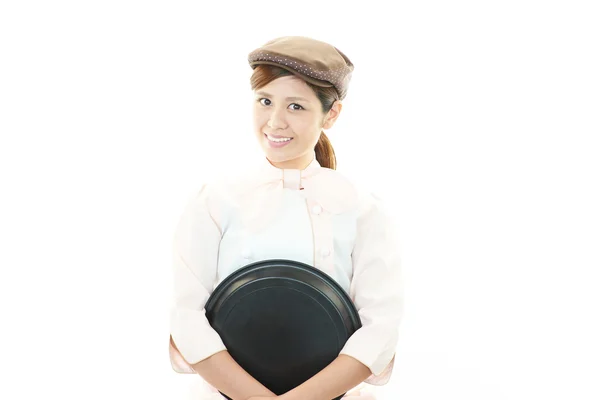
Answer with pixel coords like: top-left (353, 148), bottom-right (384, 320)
top-left (254, 76), bottom-right (341, 169)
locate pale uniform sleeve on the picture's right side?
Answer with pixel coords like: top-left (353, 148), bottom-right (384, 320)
top-left (340, 196), bottom-right (403, 385)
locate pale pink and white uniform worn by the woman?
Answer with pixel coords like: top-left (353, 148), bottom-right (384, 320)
top-left (169, 36), bottom-right (403, 400)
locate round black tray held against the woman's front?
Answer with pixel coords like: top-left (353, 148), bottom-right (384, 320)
top-left (205, 259), bottom-right (362, 400)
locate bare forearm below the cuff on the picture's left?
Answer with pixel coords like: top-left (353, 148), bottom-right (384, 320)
top-left (192, 351), bottom-right (276, 400)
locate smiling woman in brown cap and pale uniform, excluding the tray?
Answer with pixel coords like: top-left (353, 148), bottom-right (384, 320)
top-left (170, 36), bottom-right (402, 400)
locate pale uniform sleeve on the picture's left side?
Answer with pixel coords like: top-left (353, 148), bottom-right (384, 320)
top-left (169, 185), bottom-right (226, 373)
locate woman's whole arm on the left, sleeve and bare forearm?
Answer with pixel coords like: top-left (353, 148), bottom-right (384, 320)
top-left (170, 186), bottom-right (275, 400)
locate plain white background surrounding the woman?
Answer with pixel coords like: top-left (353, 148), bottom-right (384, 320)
top-left (0, 0), bottom-right (600, 400)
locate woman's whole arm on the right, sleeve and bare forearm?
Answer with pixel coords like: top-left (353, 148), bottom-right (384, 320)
top-left (283, 192), bottom-right (402, 400)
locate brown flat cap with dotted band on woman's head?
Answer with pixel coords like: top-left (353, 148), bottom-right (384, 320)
top-left (248, 36), bottom-right (354, 100)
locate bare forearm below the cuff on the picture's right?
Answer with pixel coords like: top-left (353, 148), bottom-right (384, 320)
top-left (280, 354), bottom-right (371, 400)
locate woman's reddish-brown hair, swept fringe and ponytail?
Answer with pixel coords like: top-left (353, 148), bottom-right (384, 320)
top-left (250, 64), bottom-right (339, 169)
